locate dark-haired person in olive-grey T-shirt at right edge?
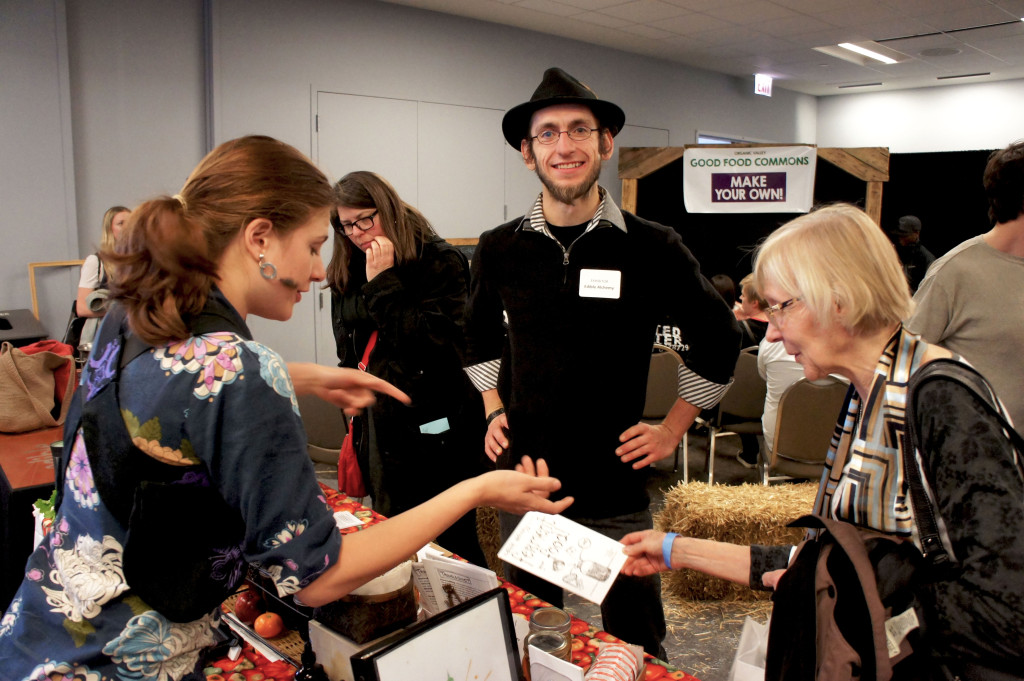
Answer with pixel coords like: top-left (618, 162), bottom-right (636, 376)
top-left (906, 140), bottom-right (1024, 432)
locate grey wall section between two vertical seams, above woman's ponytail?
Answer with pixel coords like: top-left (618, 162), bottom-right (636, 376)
top-left (68, 0), bottom-right (206, 251)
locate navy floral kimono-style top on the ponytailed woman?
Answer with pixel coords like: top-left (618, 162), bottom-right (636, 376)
top-left (0, 290), bottom-right (341, 681)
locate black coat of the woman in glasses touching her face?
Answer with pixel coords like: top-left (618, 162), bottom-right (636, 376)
top-left (331, 239), bottom-right (485, 515)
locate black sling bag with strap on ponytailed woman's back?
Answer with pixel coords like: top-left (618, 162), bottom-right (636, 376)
top-left (58, 306), bottom-right (245, 622)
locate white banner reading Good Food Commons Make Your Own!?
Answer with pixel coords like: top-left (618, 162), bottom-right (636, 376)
top-left (683, 146), bottom-right (817, 213)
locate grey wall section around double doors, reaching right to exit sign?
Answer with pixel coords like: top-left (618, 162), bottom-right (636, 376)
top-left (207, 0), bottom-right (815, 361)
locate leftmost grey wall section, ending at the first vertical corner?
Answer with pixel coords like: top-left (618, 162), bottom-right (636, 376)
top-left (0, 0), bottom-right (78, 335)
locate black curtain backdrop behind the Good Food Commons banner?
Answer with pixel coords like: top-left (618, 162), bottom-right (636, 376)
top-left (637, 150), bottom-right (991, 283)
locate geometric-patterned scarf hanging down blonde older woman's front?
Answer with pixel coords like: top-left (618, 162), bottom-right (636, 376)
top-left (814, 326), bottom-right (928, 537)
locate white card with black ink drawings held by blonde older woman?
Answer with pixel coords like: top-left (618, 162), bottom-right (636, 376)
top-left (498, 511), bottom-right (626, 603)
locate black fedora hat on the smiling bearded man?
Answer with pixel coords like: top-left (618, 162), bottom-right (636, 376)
top-left (502, 68), bottom-right (626, 150)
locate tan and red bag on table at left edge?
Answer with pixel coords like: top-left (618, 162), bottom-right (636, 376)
top-left (0, 341), bottom-right (75, 433)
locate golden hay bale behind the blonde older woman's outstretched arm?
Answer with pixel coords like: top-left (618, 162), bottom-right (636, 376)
top-left (654, 482), bottom-right (818, 601)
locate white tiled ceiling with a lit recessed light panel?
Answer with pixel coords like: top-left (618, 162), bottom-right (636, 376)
top-left (385, 0), bottom-right (1024, 95)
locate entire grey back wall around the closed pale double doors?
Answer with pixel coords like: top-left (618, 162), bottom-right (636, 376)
top-left (0, 0), bottom-right (816, 359)
